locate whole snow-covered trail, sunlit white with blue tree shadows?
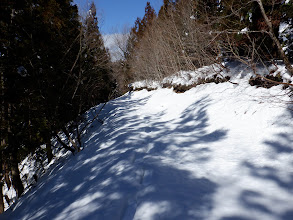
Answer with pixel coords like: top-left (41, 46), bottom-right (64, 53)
top-left (0, 81), bottom-right (293, 220)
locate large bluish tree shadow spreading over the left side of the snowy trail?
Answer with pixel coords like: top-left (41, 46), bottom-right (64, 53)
top-left (6, 91), bottom-right (227, 220)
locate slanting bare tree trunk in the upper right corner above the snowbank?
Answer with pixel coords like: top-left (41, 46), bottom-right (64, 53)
top-left (256, 0), bottom-right (293, 76)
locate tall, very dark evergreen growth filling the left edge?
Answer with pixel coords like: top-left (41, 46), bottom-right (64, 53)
top-left (0, 0), bottom-right (79, 211)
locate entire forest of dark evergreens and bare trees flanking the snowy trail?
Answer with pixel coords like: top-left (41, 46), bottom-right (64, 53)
top-left (0, 0), bottom-right (293, 213)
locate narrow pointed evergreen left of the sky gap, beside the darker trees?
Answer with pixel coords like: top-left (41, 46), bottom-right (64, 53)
top-left (76, 3), bottom-right (112, 111)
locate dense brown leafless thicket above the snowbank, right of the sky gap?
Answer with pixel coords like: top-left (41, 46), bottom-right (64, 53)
top-left (126, 0), bottom-right (219, 80)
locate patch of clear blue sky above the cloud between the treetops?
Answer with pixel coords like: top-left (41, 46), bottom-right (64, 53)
top-left (74, 0), bottom-right (163, 34)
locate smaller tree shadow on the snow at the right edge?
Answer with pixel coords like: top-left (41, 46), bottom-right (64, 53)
top-left (236, 106), bottom-right (293, 220)
